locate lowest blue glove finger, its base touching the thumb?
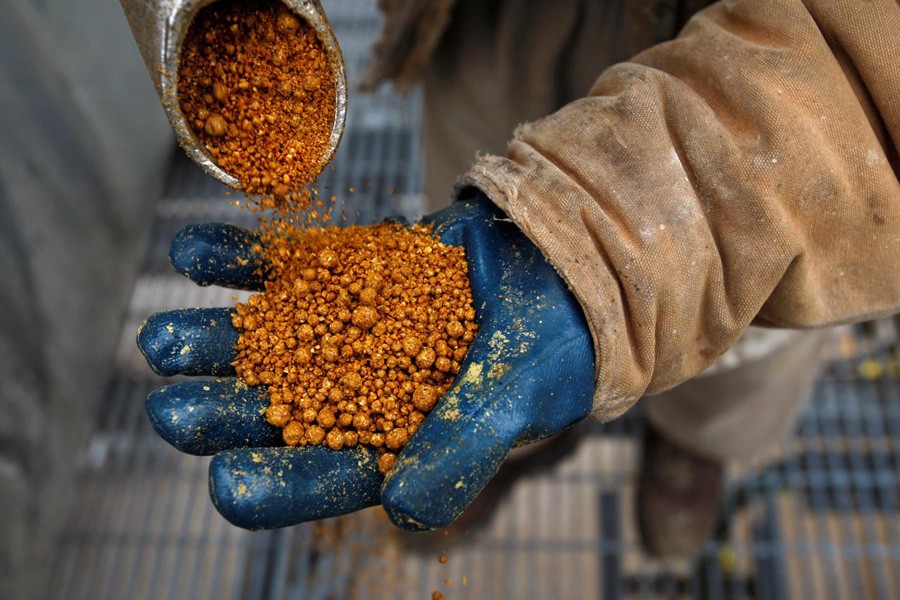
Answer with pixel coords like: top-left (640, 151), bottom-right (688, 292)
top-left (209, 446), bottom-right (382, 529)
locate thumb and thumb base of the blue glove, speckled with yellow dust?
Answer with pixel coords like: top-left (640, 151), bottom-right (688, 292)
top-left (381, 328), bottom-right (593, 530)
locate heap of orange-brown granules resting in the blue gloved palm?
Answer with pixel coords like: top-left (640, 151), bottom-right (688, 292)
top-left (232, 221), bottom-right (477, 473)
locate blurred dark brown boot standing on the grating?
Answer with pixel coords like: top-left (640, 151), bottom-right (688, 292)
top-left (637, 423), bottom-right (725, 560)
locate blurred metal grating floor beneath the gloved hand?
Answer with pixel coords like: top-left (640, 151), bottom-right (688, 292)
top-left (44, 0), bottom-right (900, 600)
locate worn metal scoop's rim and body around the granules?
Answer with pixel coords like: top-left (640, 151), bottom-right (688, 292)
top-left (121, 0), bottom-right (347, 189)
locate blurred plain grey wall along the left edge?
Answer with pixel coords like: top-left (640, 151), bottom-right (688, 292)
top-left (0, 0), bottom-right (173, 599)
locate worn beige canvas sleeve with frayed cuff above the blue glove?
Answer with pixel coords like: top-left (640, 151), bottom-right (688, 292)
top-left (457, 0), bottom-right (900, 419)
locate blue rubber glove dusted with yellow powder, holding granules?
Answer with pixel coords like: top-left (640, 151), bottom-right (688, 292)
top-left (138, 193), bottom-right (594, 530)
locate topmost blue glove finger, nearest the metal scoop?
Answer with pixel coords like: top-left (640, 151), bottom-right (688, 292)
top-left (169, 223), bottom-right (264, 290)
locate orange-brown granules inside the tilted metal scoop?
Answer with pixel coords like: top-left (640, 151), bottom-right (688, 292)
top-left (178, 0), bottom-right (336, 199)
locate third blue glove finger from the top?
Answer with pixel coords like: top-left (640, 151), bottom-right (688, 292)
top-left (146, 379), bottom-right (282, 456)
